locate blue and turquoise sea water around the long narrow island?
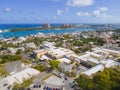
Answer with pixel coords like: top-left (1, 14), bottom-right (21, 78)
top-left (0, 24), bottom-right (93, 38)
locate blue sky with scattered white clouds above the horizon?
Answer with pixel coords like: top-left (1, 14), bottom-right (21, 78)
top-left (0, 0), bottom-right (120, 24)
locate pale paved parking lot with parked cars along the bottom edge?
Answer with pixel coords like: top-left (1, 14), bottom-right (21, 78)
top-left (31, 75), bottom-right (74, 90)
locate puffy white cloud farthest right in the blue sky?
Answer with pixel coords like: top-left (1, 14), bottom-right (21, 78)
top-left (93, 7), bottom-right (114, 19)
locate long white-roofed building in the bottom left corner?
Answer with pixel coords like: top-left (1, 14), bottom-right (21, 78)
top-left (0, 68), bottom-right (40, 90)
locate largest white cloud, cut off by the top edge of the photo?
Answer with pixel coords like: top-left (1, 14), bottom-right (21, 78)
top-left (66, 0), bottom-right (94, 7)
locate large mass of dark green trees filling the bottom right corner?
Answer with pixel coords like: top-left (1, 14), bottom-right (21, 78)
top-left (76, 67), bottom-right (120, 90)
